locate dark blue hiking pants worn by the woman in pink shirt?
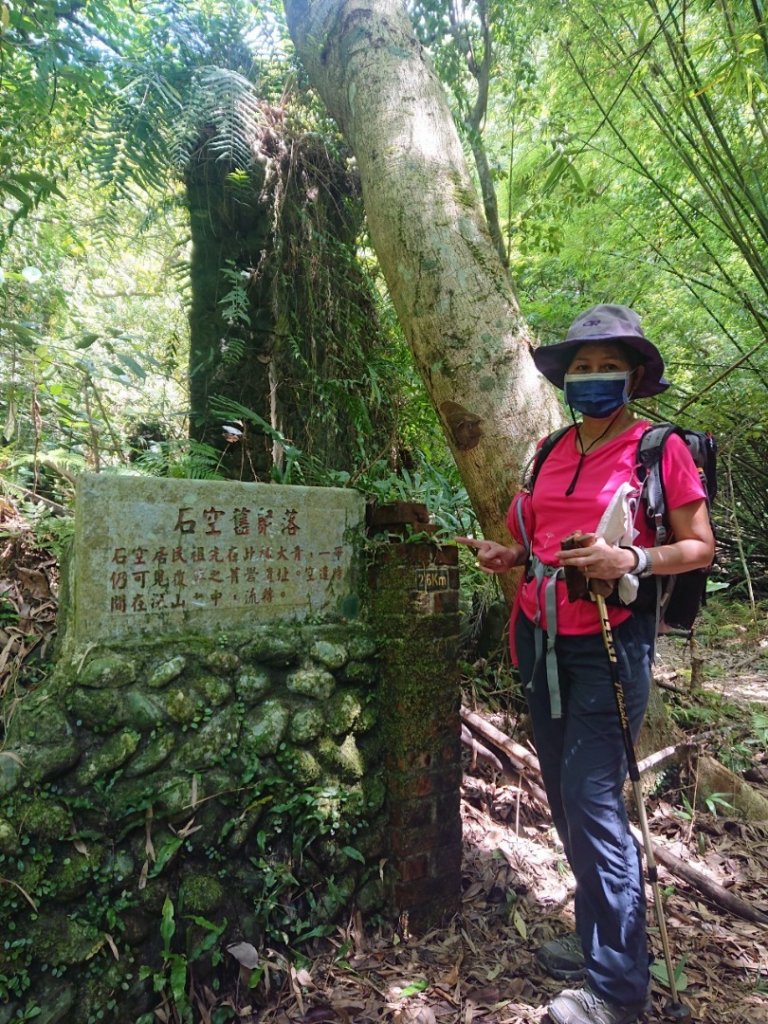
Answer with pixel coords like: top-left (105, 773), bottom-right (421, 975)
top-left (516, 614), bottom-right (655, 1006)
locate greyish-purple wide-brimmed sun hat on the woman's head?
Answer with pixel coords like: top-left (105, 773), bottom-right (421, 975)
top-left (532, 305), bottom-right (670, 398)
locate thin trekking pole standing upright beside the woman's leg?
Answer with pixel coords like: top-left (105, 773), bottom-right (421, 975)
top-left (592, 592), bottom-right (691, 1024)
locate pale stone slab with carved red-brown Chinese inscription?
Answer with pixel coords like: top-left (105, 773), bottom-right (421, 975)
top-left (68, 474), bottom-right (365, 642)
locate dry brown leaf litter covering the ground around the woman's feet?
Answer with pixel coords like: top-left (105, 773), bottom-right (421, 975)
top-left (243, 632), bottom-right (768, 1024)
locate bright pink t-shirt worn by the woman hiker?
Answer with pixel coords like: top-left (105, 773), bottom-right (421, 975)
top-left (507, 420), bottom-right (706, 635)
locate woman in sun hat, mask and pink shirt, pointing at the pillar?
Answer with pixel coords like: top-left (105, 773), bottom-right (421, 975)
top-left (458, 305), bottom-right (715, 1024)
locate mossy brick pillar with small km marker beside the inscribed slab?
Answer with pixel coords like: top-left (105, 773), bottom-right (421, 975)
top-left (371, 506), bottom-right (462, 931)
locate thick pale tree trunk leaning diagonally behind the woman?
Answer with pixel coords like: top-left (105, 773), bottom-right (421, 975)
top-left (285, 0), bottom-right (561, 569)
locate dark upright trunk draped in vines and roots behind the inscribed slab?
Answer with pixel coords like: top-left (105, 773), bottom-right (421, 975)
top-left (185, 104), bottom-right (393, 479)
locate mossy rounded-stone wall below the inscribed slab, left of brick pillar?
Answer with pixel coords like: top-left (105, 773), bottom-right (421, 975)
top-left (0, 623), bottom-right (388, 1024)
